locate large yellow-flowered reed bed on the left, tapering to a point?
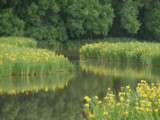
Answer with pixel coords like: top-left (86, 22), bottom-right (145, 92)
top-left (0, 44), bottom-right (73, 76)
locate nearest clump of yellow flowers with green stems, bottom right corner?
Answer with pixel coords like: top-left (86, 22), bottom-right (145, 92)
top-left (84, 80), bottom-right (160, 120)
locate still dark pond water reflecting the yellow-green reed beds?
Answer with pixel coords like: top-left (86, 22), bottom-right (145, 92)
top-left (0, 50), bottom-right (160, 120)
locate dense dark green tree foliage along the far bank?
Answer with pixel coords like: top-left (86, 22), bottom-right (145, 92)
top-left (0, 0), bottom-right (160, 45)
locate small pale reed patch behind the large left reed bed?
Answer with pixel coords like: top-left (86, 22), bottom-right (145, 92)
top-left (0, 37), bottom-right (37, 48)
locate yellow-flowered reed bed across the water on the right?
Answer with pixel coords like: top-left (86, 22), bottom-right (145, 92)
top-left (80, 41), bottom-right (160, 65)
